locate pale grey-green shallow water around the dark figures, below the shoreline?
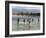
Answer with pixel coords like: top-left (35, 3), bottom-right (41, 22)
top-left (12, 15), bottom-right (40, 31)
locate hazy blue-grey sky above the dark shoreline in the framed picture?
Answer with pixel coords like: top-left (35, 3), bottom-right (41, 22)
top-left (12, 6), bottom-right (40, 13)
